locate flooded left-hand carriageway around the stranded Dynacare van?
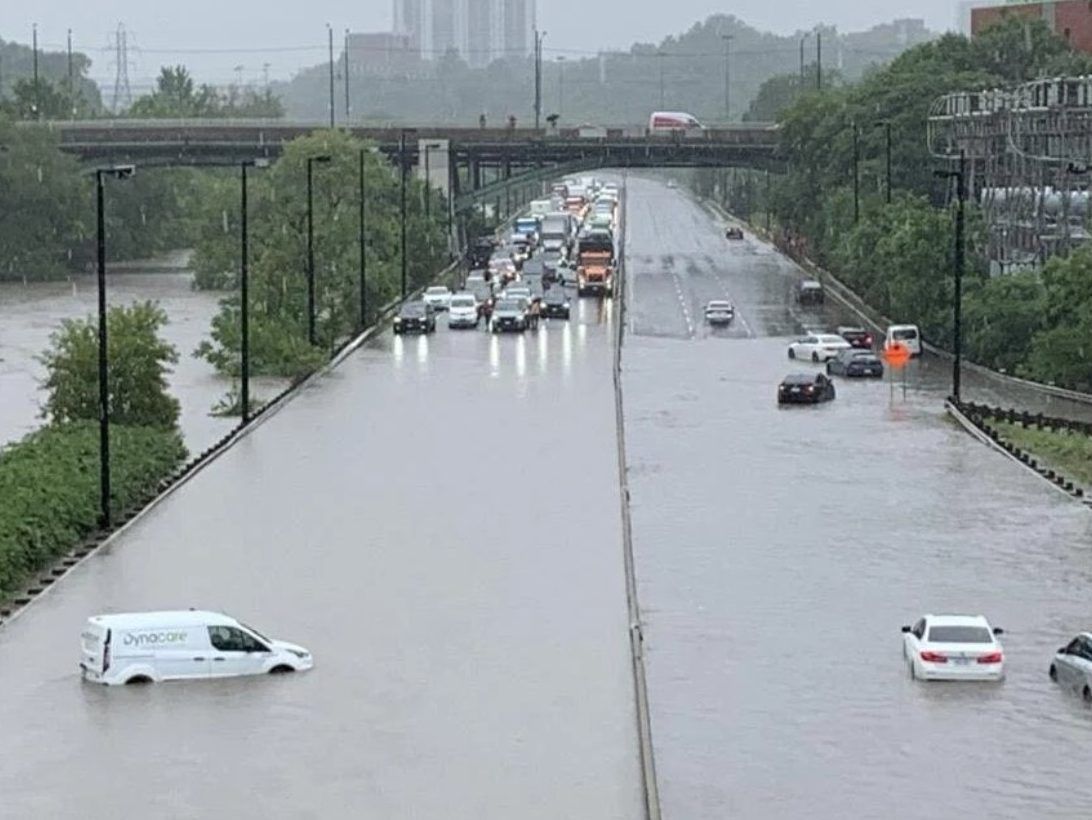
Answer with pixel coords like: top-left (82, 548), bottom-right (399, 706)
top-left (0, 292), bottom-right (640, 820)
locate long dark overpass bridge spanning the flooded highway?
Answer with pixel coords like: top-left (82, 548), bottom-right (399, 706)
top-left (46, 119), bottom-right (779, 210)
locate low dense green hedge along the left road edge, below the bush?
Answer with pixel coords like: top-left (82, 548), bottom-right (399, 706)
top-left (0, 423), bottom-right (186, 601)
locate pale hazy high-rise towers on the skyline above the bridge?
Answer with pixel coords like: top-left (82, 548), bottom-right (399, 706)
top-left (394, 0), bottom-right (535, 67)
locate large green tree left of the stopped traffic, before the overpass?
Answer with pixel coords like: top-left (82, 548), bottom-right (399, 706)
top-left (194, 131), bottom-right (447, 377)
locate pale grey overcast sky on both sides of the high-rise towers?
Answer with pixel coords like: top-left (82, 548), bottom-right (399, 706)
top-left (0, 0), bottom-right (957, 91)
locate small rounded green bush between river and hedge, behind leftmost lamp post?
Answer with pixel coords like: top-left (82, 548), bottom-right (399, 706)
top-left (41, 301), bottom-right (179, 429)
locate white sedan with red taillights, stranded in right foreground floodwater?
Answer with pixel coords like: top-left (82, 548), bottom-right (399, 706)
top-left (902, 615), bottom-right (1005, 680)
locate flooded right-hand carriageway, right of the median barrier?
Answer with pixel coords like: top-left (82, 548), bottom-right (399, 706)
top-left (624, 178), bottom-right (1092, 820)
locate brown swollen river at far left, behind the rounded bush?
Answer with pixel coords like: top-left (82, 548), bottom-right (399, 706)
top-left (0, 272), bottom-right (241, 452)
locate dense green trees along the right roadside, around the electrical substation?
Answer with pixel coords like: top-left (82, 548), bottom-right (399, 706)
top-left (699, 19), bottom-right (1092, 390)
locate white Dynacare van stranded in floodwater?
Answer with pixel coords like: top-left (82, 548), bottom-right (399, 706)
top-left (80, 609), bottom-right (314, 685)
